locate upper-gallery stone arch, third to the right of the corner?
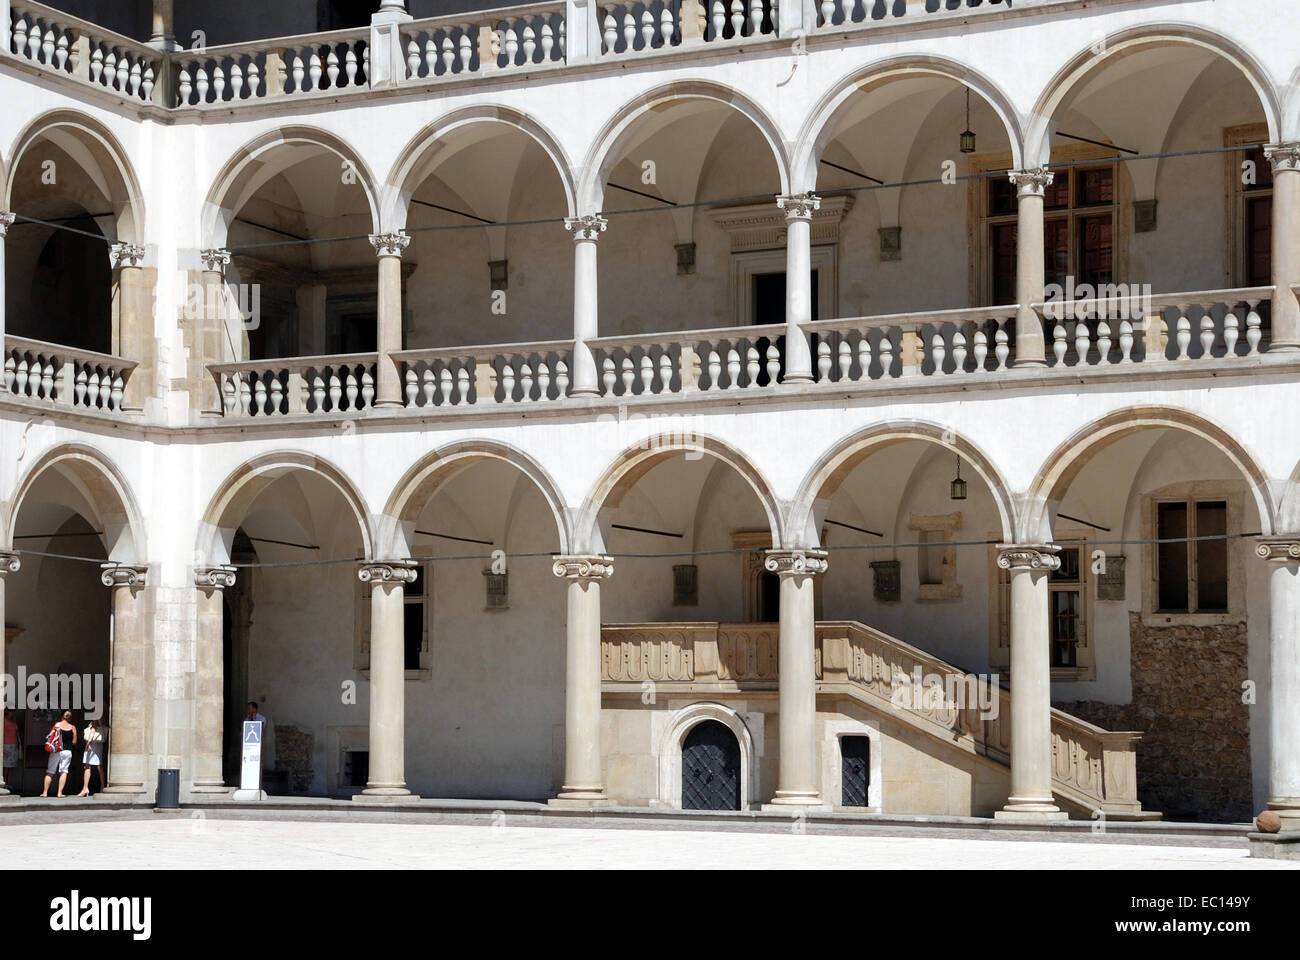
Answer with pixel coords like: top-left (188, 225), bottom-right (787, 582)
top-left (577, 81), bottom-right (790, 213)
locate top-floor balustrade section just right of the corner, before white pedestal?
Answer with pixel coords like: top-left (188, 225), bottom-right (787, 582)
top-left (173, 30), bottom-right (371, 107)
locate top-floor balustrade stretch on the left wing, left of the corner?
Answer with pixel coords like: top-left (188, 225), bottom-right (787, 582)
top-left (0, 0), bottom-right (166, 103)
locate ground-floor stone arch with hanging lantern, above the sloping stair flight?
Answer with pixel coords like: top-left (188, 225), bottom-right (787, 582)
top-left (787, 420), bottom-right (1017, 544)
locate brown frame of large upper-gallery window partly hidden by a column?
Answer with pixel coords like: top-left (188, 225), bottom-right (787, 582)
top-left (966, 143), bottom-right (1132, 306)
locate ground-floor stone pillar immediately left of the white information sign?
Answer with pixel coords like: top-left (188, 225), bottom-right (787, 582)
top-left (190, 567), bottom-right (235, 793)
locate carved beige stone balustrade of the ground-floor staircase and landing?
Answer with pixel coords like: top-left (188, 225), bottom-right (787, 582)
top-left (601, 620), bottom-right (1141, 817)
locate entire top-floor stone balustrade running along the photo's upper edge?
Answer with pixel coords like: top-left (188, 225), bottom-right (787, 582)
top-left (0, 0), bottom-right (1065, 109)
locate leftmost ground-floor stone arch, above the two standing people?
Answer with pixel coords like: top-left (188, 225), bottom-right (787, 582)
top-left (0, 444), bottom-right (148, 563)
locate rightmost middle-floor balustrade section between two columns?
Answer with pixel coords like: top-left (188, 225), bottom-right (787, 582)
top-left (1035, 286), bottom-right (1274, 367)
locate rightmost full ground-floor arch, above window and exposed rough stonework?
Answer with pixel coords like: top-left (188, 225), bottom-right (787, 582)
top-left (1017, 407), bottom-right (1277, 542)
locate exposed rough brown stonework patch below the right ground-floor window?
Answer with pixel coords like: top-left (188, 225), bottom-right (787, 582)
top-left (1054, 613), bottom-right (1253, 822)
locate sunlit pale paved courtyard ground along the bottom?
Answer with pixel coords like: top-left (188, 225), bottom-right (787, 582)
top-left (0, 817), bottom-right (1300, 870)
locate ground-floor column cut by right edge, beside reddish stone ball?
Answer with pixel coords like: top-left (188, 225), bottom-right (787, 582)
top-left (1255, 537), bottom-right (1300, 830)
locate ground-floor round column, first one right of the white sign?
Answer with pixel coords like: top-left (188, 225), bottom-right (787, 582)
top-left (352, 559), bottom-right (419, 800)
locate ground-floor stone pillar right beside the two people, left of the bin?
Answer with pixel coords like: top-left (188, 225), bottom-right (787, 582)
top-left (100, 563), bottom-right (153, 795)
